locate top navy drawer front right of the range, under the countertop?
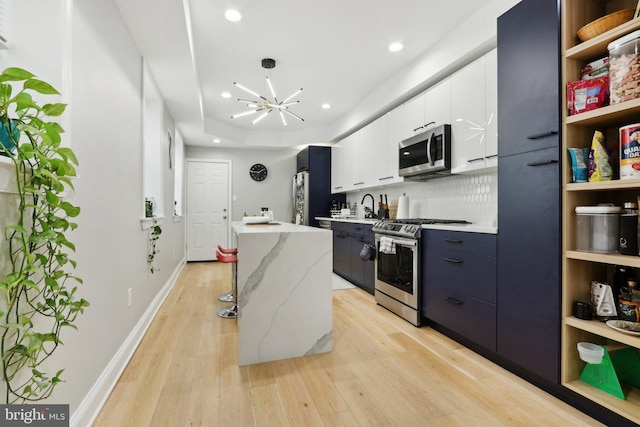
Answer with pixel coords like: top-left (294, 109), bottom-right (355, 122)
top-left (423, 230), bottom-right (497, 256)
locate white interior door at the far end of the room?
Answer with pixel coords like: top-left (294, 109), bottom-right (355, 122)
top-left (187, 161), bottom-right (231, 261)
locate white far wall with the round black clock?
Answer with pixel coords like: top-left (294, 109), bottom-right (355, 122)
top-left (185, 146), bottom-right (299, 222)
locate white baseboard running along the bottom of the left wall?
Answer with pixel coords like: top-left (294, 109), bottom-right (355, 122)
top-left (69, 258), bottom-right (186, 427)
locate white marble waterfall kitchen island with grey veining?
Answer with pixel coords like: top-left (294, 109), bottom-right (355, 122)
top-left (232, 222), bottom-right (333, 365)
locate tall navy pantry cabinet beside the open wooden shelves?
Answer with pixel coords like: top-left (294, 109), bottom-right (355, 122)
top-left (496, 0), bottom-right (561, 384)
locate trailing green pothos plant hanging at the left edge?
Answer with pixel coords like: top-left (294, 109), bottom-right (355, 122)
top-left (0, 68), bottom-right (89, 403)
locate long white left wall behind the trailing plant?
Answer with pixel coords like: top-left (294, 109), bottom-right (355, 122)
top-left (0, 0), bottom-right (185, 425)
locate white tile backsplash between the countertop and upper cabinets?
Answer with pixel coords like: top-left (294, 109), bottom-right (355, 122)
top-left (347, 172), bottom-right (498, 227)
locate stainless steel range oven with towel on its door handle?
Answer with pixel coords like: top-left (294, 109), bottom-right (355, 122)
top-left (373, 219), bottom-right (467, 326)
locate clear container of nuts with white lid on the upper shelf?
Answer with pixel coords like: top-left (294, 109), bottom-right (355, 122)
top-left (607, 30), bottom-right (640, 105)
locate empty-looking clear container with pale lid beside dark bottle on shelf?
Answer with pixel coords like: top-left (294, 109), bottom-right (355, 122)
top-left (576, 204), bottom-right (621, 254)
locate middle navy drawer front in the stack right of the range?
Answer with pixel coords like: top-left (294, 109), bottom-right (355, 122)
top-left (423, 247), bottom-right (497, 304)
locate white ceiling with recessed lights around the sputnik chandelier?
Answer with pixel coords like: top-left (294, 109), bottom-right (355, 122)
top-left (116, 0), bottom-right (491, 146)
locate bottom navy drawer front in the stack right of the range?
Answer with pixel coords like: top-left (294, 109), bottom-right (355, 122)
top-left (422, 286), bottom-right (496, 351)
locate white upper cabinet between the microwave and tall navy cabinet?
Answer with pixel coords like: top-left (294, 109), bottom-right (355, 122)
top-left (451, 49), bottom-right (498, 173)
